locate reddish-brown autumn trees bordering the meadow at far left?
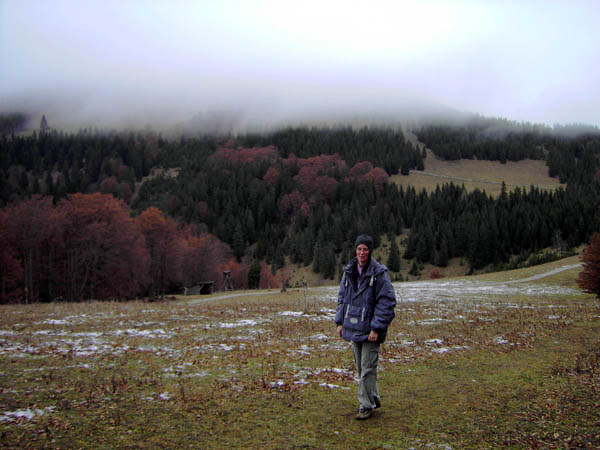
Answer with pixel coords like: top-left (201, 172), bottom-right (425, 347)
top-left (0, 193), bottom-right (279, 303)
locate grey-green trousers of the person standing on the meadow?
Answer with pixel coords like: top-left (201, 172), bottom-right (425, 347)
top-left (352, 341), bottom-right (380, 408)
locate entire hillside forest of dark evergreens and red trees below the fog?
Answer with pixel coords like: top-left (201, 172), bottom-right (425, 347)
top-left (0, 117), bottom-right (600, 302)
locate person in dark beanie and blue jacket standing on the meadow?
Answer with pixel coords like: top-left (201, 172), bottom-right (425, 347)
top-left (335, 234), bottom-right (396, 420)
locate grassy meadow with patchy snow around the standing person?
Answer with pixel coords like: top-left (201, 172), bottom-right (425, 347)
top-left (0, 258), bottom-right (600, 449)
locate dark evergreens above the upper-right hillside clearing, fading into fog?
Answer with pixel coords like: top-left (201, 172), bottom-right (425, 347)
top-left (414, 116), bottom-right (600, 184)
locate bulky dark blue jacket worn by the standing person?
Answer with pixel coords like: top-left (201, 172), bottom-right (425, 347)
top-left (335, 258), bottom-right (396, 343)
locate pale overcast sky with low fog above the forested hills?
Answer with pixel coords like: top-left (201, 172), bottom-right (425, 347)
top-left (0, 0), bottom-right (600, 130)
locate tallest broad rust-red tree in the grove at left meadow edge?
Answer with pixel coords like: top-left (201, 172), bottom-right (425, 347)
top-left (51, 193), bottom-right (149, 300)
